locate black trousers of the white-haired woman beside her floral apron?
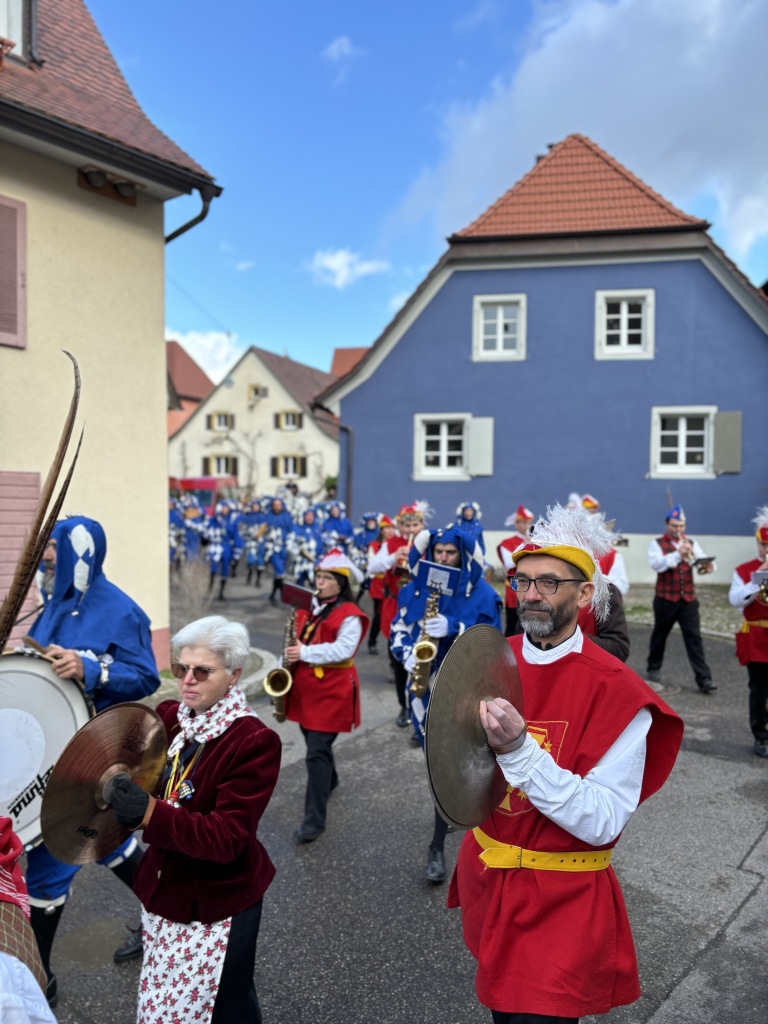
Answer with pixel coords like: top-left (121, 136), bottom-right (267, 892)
top-left (211, 900), bottom-right (261, 1024)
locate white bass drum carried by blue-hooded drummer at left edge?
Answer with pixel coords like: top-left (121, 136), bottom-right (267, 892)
top-left (0, 653), bottom-right (91, 848)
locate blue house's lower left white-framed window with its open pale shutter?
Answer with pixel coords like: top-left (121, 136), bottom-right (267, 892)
top-left (413, 413), bottom-right (494, 480)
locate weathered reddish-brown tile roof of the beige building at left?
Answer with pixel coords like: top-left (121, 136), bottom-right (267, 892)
top-left (0, 0), bottom-right (210, 177)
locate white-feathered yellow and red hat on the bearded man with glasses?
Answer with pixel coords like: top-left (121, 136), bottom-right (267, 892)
top-left (512, 505), bottom-right (613, 622)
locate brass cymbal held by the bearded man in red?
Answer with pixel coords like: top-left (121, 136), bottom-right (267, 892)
top-left (424, 625), bottom-right (522, 828)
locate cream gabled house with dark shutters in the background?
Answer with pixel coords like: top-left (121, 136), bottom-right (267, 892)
top-left (168, 347), bottom-right (339, 496)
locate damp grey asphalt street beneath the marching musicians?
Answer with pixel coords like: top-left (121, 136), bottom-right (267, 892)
top-left (45, 579), bottom-right (768, 1024)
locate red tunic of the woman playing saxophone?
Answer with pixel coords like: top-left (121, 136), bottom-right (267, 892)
top-left (286, 602), bottom-right (368, 732)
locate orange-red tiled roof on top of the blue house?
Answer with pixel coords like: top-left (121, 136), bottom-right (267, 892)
top-left (451, 135), bottom-right (710, 241)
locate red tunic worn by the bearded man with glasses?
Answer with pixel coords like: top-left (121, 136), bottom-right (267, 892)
top-left (447, 636), bottom-right (683, 1017)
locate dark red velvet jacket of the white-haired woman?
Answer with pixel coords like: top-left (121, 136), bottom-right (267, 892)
top-left (133, 700), bottom-right (281, 924)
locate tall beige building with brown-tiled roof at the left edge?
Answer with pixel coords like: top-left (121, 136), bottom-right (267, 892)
top-left (0, 0), bottom-right (221, 667)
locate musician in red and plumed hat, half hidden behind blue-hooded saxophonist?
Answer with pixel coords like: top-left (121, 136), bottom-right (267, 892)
top-left (368, 502), bottom-right (432, 729)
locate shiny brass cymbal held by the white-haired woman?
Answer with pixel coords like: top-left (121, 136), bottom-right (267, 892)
top-left (40, 703), bottom-right (167, 864)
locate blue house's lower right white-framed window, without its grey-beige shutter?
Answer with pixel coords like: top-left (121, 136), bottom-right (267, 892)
top-left (650, 406), bottom-right (717, 478)
